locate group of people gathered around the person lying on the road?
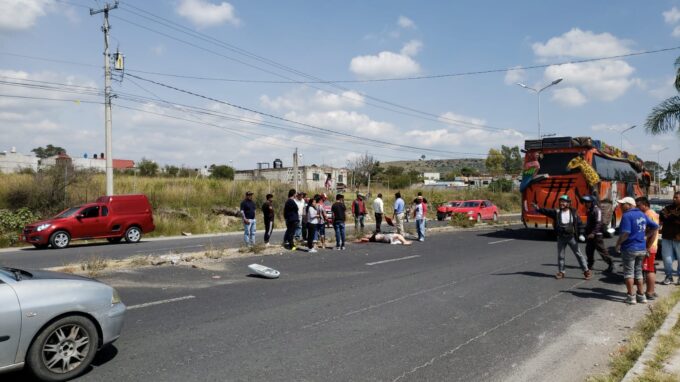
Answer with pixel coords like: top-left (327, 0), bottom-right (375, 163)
top-left (239, 189), bottom-right (427, 253)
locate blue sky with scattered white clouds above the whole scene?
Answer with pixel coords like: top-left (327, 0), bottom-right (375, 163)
top-left (0, 0), bottom-right (680, 169)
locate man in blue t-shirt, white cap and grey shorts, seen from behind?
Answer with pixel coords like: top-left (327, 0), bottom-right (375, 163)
top-left (615, 196), bottom-right (659, 305)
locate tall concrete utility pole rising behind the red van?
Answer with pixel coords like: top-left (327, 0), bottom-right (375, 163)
top-left (90, 0), bottom-right (118, 196)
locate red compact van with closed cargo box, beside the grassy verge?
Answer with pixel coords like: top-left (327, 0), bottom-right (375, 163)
top-left (19, 195), bottom-right (156, 249)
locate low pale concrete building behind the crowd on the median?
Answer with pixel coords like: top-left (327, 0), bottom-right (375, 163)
top-left (234, 163), bottom-right (347, 190)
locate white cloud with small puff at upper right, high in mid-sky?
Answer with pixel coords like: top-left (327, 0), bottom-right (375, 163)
top-left (349, 40), bottom-right (422, 78)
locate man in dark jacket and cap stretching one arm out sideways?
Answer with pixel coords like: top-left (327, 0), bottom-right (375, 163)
top-left (533, 195), bottom-right (592, 280)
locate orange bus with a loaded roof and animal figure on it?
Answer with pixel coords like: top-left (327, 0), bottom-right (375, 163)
top-left (520, 137), bottom-right (650, 233)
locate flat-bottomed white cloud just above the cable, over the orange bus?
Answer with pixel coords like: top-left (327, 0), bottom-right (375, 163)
top-left (531, 28), bottom-right (631, 58)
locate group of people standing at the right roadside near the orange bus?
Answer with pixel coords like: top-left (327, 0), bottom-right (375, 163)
top-left (533, 192), bottom-right (680, 304)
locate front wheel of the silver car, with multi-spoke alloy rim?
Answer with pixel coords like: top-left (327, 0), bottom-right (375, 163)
top-left (26, 316), bottom-right (99, 382)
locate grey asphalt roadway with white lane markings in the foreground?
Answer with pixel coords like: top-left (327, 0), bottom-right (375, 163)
top-left (5, 226), bottom-right (636, 381)
